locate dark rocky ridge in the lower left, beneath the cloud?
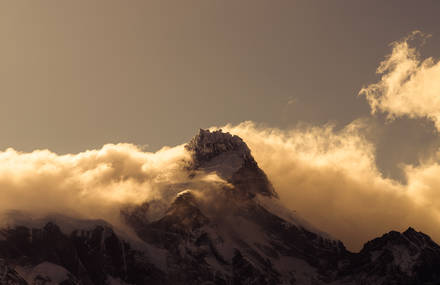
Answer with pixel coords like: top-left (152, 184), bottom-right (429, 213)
top-left (0, 223), bottom-right (163, 285)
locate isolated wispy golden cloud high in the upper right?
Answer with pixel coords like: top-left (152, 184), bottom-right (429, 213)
top-left (359, 31), bottom-right (440, 131)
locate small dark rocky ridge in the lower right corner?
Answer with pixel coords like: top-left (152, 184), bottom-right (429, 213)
top-left (341, 228), bottom-right (440, 284)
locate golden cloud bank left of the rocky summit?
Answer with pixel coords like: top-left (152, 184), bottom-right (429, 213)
top-left (0, 144), bottom-right (190, 224)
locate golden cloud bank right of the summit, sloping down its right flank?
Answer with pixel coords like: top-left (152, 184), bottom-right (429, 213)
top-left (222, 121), bottom-right (440, 249)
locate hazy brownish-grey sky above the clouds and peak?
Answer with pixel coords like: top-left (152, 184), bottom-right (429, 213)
top-left (0, 0), bottom-right (440, 177)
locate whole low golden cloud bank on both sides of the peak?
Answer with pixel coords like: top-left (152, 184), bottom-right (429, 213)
top-left (0, 120), bottom-right (440, 249)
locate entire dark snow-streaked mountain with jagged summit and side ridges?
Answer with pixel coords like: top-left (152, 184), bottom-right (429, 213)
top-left (0, 130), bottom-right (440, 285)
